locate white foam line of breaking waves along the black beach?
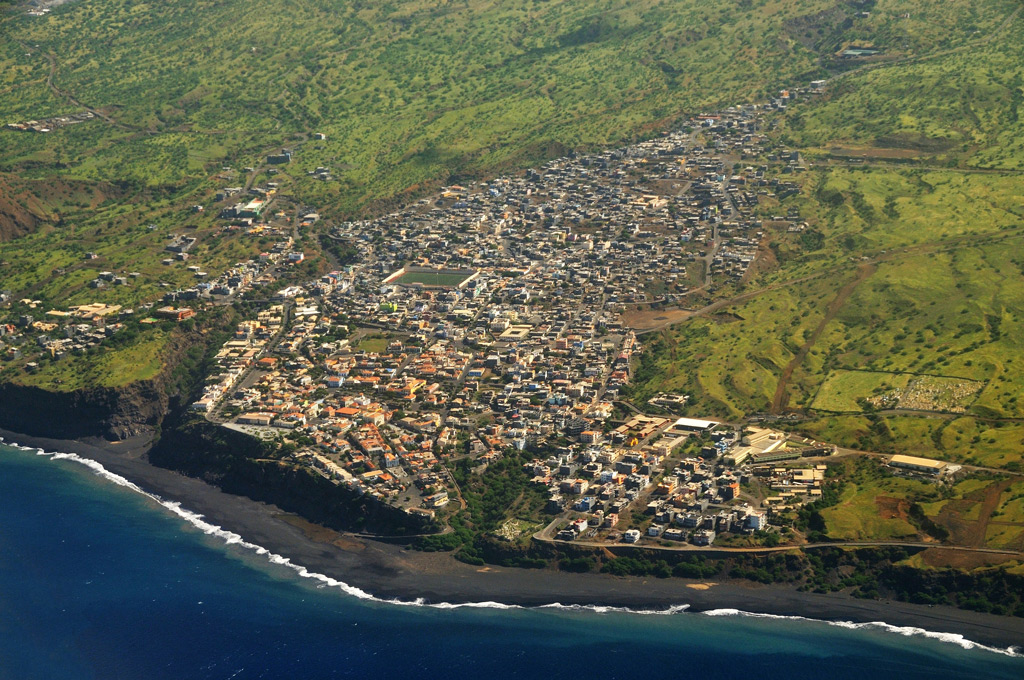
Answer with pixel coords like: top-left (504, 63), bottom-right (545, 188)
top-left (0, 437), bottom-right (1024, 656)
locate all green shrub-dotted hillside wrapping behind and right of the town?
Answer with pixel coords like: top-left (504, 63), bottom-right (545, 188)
top-left (0, 0), bottom-right (1021, 409)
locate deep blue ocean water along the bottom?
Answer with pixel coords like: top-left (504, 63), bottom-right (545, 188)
top-left (0, 445), bottom-right (1024, 680)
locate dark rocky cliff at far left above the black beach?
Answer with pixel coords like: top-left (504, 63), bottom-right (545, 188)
top-left (0, 378), bottom-right (169, 440)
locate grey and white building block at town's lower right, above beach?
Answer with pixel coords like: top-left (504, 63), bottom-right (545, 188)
top-left (526, 416), bottom-right (829, 546)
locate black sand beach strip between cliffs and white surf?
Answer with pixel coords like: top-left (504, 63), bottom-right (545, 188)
top-left (0, 429), bottom-right (1024, 650)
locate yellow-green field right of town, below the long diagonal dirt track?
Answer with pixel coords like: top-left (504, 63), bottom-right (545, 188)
top-left (638, 204), bottom-right (1024, 426)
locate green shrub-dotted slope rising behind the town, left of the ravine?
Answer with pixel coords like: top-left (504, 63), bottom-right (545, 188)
top-left (0, 0), bottom-right (847, 193)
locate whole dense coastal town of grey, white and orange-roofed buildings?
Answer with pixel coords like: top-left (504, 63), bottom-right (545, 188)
top-left (182, 92), bottom-right (856, 545)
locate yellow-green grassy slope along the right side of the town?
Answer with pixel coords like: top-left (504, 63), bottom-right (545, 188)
top-left (642, 5), bottom-right (1024, 465)
